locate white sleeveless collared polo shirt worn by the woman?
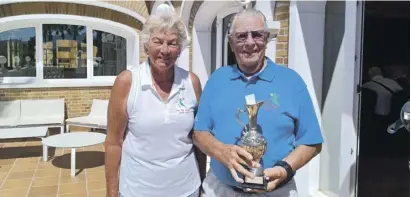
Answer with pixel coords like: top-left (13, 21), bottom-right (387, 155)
top-left (119, 61), bottom-right (201, 197)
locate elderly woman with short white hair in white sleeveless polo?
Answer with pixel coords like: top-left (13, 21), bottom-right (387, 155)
top-left (105, 4), bottom-right (205, 197)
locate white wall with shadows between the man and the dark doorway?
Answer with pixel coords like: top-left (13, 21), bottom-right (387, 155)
top-left (289, 1), bottom-right (357, 197)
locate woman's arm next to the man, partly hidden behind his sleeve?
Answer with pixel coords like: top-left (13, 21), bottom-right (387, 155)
top-left (190, 72), bottom-right (207, 182)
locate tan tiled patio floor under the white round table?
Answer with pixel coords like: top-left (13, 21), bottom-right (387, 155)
top-left (0, 130), bottom-right (105, 197)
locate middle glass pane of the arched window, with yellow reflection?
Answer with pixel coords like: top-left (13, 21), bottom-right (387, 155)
top-left (43, 24), bottom-right (87, 79)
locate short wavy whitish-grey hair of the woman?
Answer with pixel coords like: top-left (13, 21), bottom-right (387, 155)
top-left (140, 6), bottom-right (188, 53)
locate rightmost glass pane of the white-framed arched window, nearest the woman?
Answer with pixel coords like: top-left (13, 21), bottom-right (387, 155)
top-left (93, 30), bottom-right (127, 76)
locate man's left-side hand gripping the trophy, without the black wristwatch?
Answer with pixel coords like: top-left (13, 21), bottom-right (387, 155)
top-left (216, 144), bottom-right (260, 183)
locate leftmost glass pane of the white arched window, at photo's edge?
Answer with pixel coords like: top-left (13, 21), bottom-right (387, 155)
top-left (0, 27), bottom-right (36, 77)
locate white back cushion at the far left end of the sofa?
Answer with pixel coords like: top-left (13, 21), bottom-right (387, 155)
top-left (0, 100), bottom-right (20, 127)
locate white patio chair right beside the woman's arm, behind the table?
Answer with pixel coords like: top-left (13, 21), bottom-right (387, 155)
top-left (66, 99), bottom-right (108, 132)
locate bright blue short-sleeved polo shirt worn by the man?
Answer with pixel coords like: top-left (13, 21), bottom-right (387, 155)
top-left (194, 58), bottom-right (323, 186)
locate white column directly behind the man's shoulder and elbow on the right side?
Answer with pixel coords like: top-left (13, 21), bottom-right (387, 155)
top-left (288, 1), bottom-right (325, 197)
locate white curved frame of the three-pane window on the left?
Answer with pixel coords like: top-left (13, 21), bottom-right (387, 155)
top-left (0, 14), bottom-right (139, 88)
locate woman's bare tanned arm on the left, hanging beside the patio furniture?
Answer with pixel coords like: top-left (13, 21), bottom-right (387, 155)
top-left (105, 71), bottom-right (131, 197)
